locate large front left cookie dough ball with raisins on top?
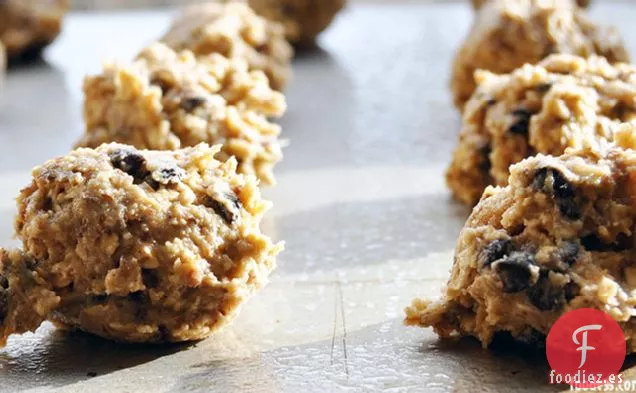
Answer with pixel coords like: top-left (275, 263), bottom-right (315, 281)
top-left (0, 144), bottom-right (282, 343)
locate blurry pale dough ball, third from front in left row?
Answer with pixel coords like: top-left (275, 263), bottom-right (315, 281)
top-left (161, 2), bottom-right (294, 90)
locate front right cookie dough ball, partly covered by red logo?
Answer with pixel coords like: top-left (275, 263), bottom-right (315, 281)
top-left (406, 126), bottom-right (636, 353)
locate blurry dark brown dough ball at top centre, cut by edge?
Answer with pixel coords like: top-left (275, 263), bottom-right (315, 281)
top-left (248, 0), bottom-right (346, 46)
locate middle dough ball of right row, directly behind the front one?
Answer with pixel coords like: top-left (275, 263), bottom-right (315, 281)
top-left (446, 55), bottom-right (636, 205)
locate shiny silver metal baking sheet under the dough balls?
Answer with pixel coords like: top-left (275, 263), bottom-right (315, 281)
top-left (0, 0), bottom-right (636, 392)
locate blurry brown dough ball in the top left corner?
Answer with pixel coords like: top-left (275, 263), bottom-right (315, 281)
top-left (0, 0), bottom-right (68, 60)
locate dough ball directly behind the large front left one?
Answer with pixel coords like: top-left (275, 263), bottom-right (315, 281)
top-left (78, 44), bottom-right (286, 184)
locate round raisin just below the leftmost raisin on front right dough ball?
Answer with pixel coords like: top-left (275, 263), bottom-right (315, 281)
top-left (492, 251), bottom-right (539, 293)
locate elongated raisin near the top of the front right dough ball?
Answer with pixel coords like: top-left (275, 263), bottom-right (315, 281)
top-left (532, 167), bottom-right (581, 220)
